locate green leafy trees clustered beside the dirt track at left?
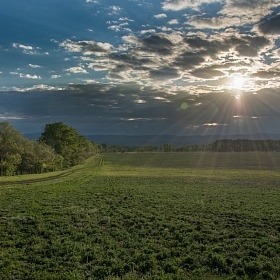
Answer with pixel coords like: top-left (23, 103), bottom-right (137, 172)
top-left (0, 121), bottom-right (98, 176)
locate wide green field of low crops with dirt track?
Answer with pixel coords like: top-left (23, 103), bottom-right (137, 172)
top-left (0, 153), bottom-right (280, 280)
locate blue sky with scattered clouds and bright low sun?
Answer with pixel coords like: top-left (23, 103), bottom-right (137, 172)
top-left (0, 0), bottom-right (280, 135)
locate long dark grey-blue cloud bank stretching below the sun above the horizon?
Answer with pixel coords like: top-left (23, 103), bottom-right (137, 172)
top-left (0, 81), bottom-right (280, 134)
